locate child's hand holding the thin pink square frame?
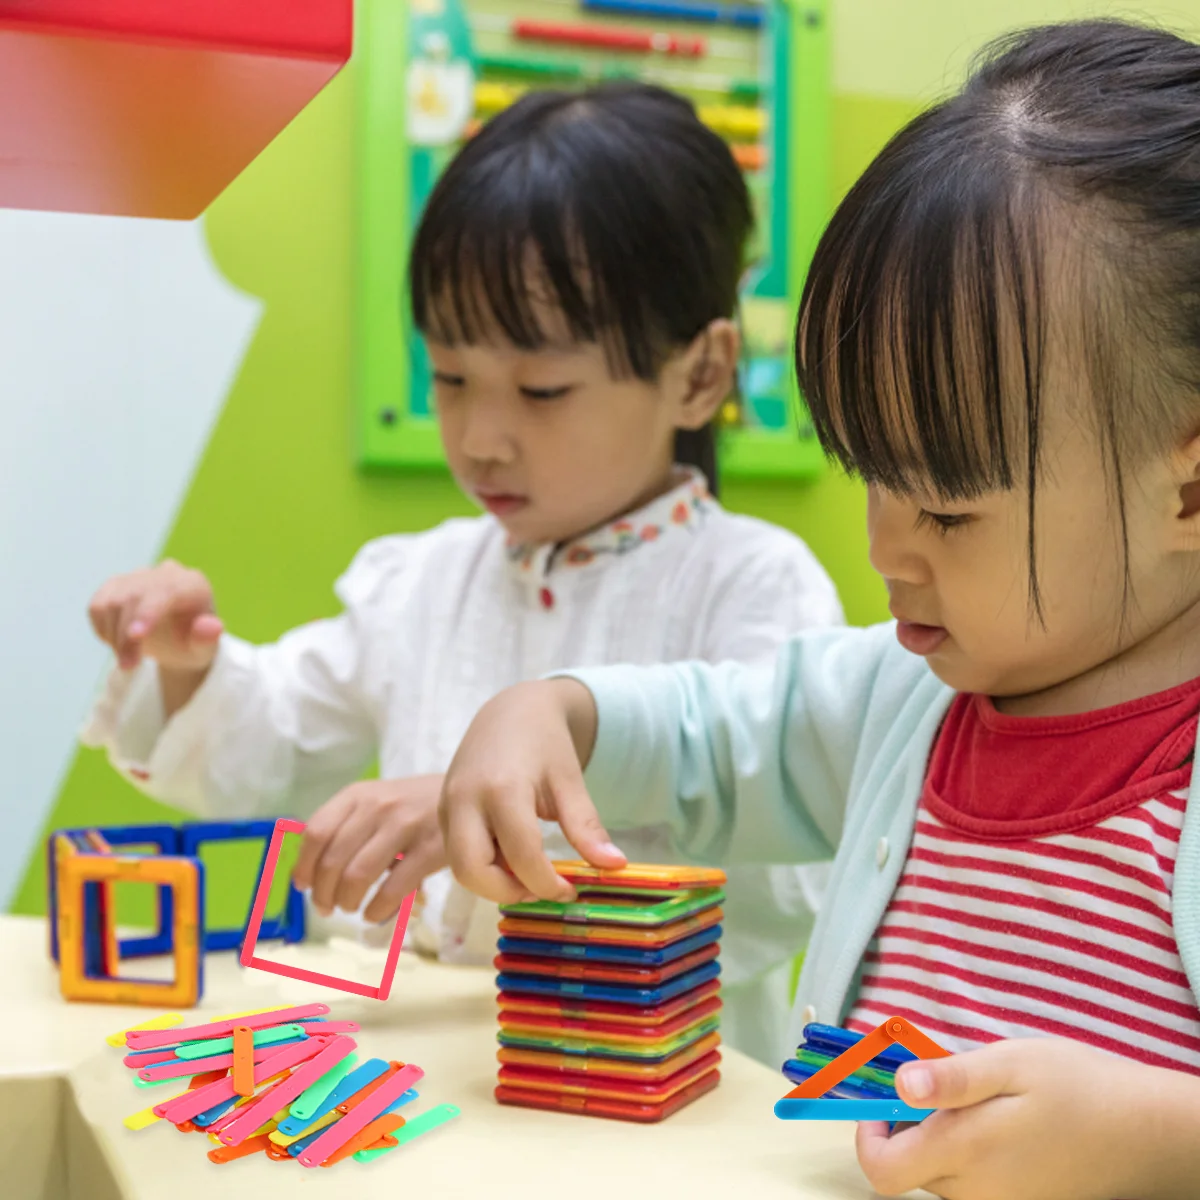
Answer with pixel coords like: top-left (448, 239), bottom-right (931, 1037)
top-left (292, 775), bottom-right (446, 922)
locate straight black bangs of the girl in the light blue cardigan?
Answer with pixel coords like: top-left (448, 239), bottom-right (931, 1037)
top-left (796, 110), bottom-right (1044, 500)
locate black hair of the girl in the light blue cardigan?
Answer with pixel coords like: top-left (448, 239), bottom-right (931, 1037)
top-left (796, 20), bottom-right (1200, 618)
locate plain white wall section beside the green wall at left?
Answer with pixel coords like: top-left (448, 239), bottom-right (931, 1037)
top-left (0, 211), bottom-right (260, 911)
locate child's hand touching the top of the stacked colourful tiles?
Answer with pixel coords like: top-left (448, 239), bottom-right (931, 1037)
top-left (440, 679), bottom-right (625, 904)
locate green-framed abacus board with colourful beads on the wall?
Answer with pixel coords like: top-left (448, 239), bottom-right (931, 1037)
top-left (355, 0), bottom-right (832, 478)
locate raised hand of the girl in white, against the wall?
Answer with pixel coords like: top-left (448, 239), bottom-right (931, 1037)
top-left (88, 560), bottom-right (222, 679)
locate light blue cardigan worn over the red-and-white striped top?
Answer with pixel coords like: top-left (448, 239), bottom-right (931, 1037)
top-left (563, 624), bottom-right (1200, 1049)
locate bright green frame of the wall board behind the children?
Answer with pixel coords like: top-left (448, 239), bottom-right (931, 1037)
top-left (352, 0), bottom-right (832, 480)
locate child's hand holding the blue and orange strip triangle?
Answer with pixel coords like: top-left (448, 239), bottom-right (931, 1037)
top-left (858, 1038), bottom-right (1200, 1200)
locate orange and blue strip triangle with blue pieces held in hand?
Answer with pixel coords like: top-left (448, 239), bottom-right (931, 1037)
top-left (775, 1016), bottom-right (949, 1123)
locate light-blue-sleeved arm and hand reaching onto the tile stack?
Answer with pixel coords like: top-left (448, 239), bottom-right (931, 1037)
top-left (442, 626), bottom-right (902, 902)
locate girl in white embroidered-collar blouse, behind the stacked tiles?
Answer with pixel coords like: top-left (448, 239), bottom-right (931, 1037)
top-left (86, 85), bottom-right (841, 1061)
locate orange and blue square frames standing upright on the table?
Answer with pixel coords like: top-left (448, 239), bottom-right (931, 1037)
top-left (47, 821), bottom-right (305, 1008)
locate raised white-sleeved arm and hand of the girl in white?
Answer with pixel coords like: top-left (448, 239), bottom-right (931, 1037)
top-left (84, 552), bottom-right (395, 818)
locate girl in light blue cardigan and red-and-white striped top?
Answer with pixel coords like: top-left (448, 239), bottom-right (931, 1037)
top-left (443, 22), bottom-right (1200, 1200)
